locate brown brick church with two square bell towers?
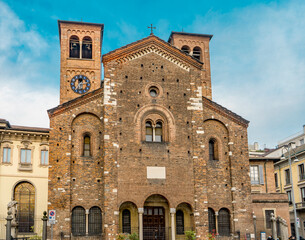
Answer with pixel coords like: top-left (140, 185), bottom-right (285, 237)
top-left (48, 21), bottom-right (254, 240)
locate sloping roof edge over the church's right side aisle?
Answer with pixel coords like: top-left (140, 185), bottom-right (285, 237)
top-left (202, 97), bottom-right (249, 127)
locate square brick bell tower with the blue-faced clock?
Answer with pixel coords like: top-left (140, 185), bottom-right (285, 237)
top-left (58, 20), bottom-right (104, 104)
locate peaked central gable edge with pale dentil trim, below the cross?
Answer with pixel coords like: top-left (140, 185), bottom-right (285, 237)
top-left (102, 35), bottom-right (204, 69)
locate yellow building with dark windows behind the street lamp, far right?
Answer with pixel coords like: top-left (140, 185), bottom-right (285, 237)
top-left (274, 139), bottom-right (305, 237)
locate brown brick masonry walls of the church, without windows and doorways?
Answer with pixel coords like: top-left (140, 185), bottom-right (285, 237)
top-left (49, 24), bottom-right (253, 239)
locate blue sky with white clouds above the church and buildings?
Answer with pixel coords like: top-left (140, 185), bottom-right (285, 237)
top-left (0, 0), bottom-right (305, 148)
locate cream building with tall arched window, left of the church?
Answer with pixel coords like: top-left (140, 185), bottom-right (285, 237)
top-left (0, 119), bottom-right (49, 239)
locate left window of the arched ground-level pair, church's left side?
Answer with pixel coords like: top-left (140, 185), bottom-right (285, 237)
top-left (72, 207), bottom-right (86, 236)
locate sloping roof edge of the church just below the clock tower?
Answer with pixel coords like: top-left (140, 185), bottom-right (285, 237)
top-left (47, 87), bottom-right (104, 118)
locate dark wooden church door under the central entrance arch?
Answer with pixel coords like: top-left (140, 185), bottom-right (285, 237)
top-left (143, 207), bottom-right (166, 240)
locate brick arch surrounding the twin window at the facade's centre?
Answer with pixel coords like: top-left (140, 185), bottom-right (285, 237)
top-left (134, 104), bottom-right (176, 142)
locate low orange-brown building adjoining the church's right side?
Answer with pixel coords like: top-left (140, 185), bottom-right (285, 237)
top-left (250, 155), bottom-right (290, 239)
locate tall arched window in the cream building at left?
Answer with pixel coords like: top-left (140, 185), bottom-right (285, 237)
top-left (14, 182), bottom-right (35, 233)
